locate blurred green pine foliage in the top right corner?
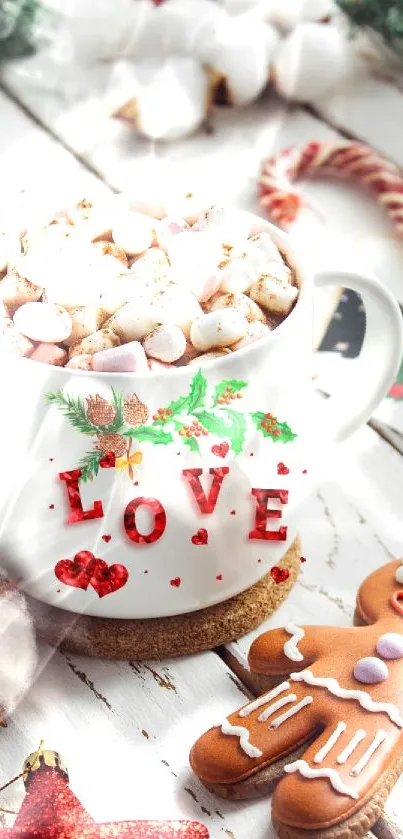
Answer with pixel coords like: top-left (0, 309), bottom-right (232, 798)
top-left (337, 0), bottom-right (403, 55)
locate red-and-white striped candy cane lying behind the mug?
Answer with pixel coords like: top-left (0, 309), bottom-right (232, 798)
top-left (259, 140), bottom-right (403, 235)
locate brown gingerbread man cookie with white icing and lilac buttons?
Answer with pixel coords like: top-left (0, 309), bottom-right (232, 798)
top-left (190, 561), bottom-right (403, 839)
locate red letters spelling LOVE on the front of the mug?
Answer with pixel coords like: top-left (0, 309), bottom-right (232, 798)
top-left (59, 466), bottom-right (288, 545)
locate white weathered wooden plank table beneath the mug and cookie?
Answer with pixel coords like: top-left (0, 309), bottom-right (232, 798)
top-left (0, 60), bottom-right (403, 839)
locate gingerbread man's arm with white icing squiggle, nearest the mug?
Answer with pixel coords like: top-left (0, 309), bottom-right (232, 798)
top-left (248, 621), bottom-right (343, 677)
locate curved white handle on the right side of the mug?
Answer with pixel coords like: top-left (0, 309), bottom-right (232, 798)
top-left (315, 270), bottom-right (403, 441)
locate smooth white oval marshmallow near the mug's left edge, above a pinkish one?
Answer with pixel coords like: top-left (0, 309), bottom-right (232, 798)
top-left (14, 303), bottom-right (72, 344)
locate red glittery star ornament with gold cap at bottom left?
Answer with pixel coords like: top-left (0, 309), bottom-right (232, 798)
top-left (0, 746), bottom-right (209, 839)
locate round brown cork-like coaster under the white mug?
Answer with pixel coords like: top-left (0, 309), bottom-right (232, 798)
top-left (27, 536), bottom-right (301, 661)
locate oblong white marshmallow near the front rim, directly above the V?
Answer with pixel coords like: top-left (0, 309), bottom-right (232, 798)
top-left (190, 309), bottom-right (248, 350)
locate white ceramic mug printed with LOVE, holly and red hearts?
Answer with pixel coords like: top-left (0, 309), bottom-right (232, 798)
top-left (0, 218), bottom-right (402, 618)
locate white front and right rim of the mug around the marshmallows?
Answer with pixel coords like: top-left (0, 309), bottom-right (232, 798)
top-left (0, 215), bottom-right (310, 381)
